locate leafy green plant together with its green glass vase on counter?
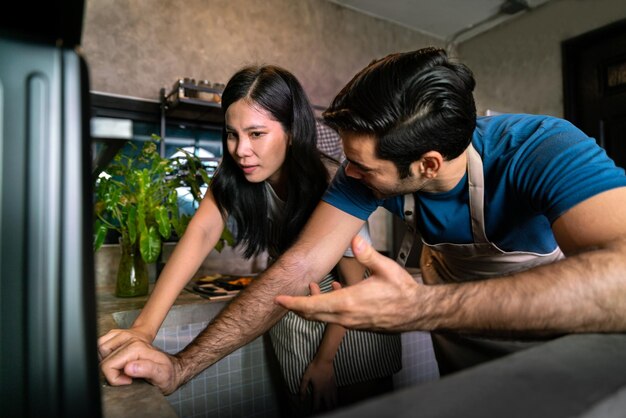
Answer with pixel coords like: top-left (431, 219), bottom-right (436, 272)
top-left (94, 135), bottom-right (233, 297)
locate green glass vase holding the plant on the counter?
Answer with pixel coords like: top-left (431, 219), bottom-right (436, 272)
top-left (115, 239), bottom-right (148, 298)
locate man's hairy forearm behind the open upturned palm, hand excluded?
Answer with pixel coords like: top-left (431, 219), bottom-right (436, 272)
top-left (426, 239), bottom-right (626, 336)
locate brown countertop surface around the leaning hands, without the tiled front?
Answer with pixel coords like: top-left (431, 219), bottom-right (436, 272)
top-left (97, 286), bottom-right (225, 418)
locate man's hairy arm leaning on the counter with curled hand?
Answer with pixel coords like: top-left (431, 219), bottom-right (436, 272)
top-left (101, 202), bottom-right (363, 394)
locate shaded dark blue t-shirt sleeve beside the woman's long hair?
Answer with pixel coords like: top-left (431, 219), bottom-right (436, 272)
top-left (322, 165), bottom-right (383, 220)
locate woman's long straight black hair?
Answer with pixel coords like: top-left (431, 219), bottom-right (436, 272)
top-left (211, 66), bottom-right (328, 258)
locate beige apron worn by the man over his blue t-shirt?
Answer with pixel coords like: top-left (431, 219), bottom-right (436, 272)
top-left (397, 144), bottom-right (564, 375)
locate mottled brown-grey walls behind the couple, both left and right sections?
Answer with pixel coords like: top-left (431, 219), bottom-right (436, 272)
top-left (82, 0), bottom-right (626, 124)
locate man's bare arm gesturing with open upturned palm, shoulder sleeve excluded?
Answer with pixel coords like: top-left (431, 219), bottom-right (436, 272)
top-left (276, 188), bottom-right (626, 336)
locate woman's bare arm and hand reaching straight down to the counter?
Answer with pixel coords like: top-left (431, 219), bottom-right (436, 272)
top-left (98, 190), bottom-right (224, 358)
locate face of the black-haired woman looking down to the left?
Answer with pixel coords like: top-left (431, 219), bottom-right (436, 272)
top-left (225, 99), bottom-right (289, 185)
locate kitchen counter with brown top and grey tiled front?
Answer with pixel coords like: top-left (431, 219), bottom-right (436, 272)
top-left (97, 272), bottom-right (437, 418)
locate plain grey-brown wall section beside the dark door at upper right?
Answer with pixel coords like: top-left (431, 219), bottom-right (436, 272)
top-left (457, 0), bottom-right (626, 117)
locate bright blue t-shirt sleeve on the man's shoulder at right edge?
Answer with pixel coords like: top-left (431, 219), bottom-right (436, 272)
top-left (512, 118), bottom-right (626, 223)
